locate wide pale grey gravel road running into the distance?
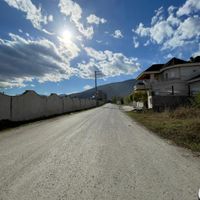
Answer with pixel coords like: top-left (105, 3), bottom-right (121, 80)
top-left (0, 104), bottom-right (200, 200)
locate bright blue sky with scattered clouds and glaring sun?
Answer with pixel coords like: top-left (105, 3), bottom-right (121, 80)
top-left (0, 0), bottom-right (200, 95)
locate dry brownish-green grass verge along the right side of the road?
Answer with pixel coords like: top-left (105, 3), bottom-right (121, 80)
top-left (127, 108), bottom-right (200, 152)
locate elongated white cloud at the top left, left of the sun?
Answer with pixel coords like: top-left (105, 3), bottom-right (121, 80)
top-left (4, 0), bottom-right (48, 30)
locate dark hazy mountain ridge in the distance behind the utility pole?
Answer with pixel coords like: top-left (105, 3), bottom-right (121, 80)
top-left (70, 79), bottom-right (136, 99)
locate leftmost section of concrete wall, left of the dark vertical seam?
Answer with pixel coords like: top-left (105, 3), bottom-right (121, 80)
top-left (0, 93), bottom-right (11, 120)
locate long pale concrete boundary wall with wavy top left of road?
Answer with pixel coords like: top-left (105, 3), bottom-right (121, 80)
top-left (0, 91), bottom-right (99, 121)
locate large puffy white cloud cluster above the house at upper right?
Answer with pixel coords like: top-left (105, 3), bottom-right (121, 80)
top-left (133, 0), bottom-right (200, 50)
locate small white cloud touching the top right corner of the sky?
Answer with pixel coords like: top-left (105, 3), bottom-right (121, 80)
top-left (176, 0), bottom-right (200, 16)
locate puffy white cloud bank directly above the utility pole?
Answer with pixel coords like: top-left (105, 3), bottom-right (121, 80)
top-left (78, 47), bottom-right (140, 78)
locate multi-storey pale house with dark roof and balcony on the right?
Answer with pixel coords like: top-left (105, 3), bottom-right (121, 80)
top-left (134, 56), bottom-right (200, 108)
